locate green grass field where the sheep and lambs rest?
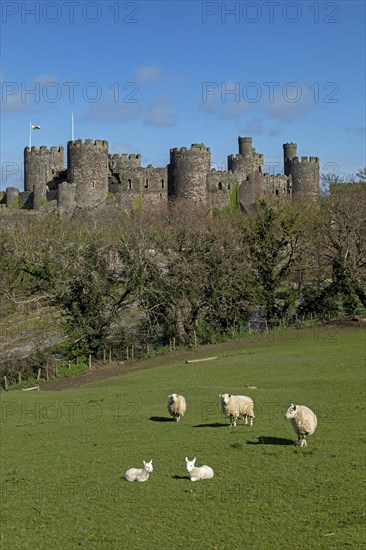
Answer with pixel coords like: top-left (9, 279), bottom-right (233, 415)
top-left (0, 326), bottom-right (366, 550)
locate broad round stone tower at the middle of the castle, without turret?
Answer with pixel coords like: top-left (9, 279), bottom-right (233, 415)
top-left (168, 143), bottom-right (211, 204)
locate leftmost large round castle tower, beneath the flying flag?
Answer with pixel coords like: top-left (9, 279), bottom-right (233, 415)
top-left (24, 145), bottom-right (64, 194)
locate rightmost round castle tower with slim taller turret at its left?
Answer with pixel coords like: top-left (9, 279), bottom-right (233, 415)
top-left (283, 143), bottom-right (320, 200)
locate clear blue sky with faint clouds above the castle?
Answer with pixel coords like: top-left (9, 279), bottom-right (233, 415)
top-left (0, 0), bottom-right (366, 190)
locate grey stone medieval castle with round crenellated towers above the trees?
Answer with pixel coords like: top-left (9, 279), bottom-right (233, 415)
top-left (2, 137), bottom-right (320, 213)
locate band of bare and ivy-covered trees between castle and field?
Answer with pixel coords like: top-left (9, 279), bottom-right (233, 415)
top-left (0, 185), bottom-right (366, 364)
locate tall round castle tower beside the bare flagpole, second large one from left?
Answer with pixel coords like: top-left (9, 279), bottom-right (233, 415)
top-left (67, 139), bottom-right (108, 208)
